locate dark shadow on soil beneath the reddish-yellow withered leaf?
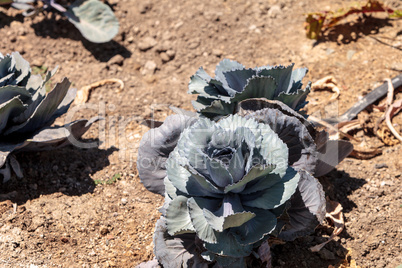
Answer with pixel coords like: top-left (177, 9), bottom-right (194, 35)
top-left (315, 15), bottom-right (393, 45)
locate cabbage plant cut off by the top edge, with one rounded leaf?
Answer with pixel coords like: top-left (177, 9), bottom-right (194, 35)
top-left (0, 0), bottom-right (119, 43)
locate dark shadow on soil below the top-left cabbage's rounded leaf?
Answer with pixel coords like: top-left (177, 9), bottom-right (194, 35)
top-left (31, 15), bottom-right (132, 62)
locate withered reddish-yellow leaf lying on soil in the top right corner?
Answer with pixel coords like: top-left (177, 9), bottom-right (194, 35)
top-left (305, 0), bottom-right (402, 39)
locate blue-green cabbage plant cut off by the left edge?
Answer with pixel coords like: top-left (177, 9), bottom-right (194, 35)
top-left (0, 52), bottom-right (98, 181)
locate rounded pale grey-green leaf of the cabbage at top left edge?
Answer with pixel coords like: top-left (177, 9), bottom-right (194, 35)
top-left (64, 0), bottom-right (119, 43)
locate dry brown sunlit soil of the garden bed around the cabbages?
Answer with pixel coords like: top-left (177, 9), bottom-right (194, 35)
top-left (0, 0), bottom-right (402, 268)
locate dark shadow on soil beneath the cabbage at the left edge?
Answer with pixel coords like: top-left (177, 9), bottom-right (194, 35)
top-left (0, 145), bottom-right (118, 205)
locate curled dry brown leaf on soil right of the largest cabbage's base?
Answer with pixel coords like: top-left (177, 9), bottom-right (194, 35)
top-left (310, 198), bottom-right (345, 252)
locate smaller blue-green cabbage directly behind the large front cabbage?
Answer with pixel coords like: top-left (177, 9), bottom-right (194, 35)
top-left (189, 59), bottom-right (310, 119)
